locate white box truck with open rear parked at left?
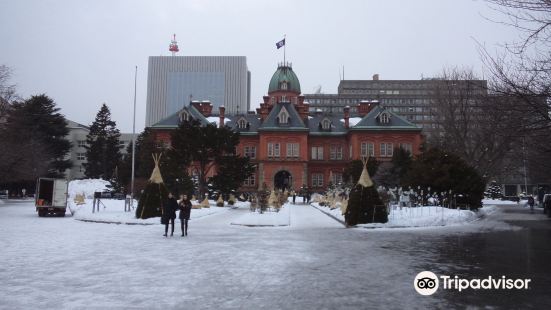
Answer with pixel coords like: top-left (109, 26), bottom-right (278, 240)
top-left (34, 178), bottom-right (68, 216)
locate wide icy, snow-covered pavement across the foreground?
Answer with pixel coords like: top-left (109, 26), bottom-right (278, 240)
top-left (0, 201), bottom-right (551, 309)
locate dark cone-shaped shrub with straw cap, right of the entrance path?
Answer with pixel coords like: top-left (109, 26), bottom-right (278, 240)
top-left (344, 162), bottom-right (388, 226)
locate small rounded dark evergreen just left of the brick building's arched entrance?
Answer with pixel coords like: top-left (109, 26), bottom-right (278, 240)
top-left (211, 155), bottom-right (255, 195)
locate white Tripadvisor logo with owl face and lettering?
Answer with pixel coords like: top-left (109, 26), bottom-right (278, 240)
top-left (413, 271), bottom-right (532, 296)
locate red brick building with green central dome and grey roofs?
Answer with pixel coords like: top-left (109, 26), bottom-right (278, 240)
top-left (150, 64), bottom-right (422, 191)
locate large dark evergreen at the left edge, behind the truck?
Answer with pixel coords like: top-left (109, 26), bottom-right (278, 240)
top-left (0, 95), bottom-right (72, 181)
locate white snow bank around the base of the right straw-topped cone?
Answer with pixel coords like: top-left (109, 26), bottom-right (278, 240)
top-left (312, 203), bottom-right (496, 228)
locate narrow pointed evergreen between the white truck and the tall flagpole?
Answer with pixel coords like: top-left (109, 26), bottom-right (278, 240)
top-left (84, 103), bottom-right (121, 180)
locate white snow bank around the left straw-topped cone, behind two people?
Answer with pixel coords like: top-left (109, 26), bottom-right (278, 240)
top-left (68, 199), bottom-right (228, 225)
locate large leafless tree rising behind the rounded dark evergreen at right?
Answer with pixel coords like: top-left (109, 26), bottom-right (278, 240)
top-left (428, 68), bottom-right (519, 178)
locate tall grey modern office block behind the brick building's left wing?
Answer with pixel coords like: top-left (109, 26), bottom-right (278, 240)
top-left (145, 56), bottom-right (251, 126)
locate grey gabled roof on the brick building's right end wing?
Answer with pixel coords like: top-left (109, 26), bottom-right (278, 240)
top-left (350, 106), bottom-right (421, 131)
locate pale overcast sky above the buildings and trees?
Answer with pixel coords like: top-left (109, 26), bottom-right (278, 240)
top-left (0, 0), bottom-right (528, 132)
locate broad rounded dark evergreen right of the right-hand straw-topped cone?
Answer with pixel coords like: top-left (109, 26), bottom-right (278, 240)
top-left (403, 148), bottom-right (485, 209)
